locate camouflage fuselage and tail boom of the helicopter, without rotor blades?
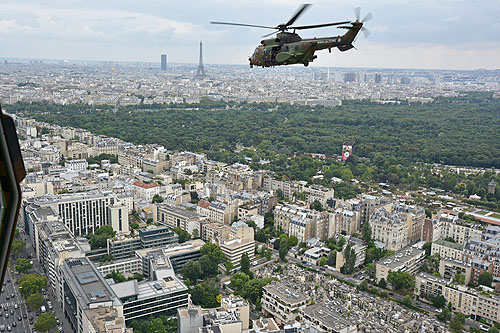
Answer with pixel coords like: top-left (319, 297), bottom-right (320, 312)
top-left (248, 22), bottom-right (363, 67)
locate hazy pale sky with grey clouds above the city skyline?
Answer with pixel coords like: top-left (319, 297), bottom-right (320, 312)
top-left (0, 0), bottom-right (500, 69)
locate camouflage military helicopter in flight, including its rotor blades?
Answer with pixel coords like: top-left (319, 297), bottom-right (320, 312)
top-left (210, 4), bottom-right (373, 68)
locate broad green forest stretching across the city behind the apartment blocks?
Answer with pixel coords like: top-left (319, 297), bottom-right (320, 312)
top-left (7, 93), bottom-right (500, 204)
